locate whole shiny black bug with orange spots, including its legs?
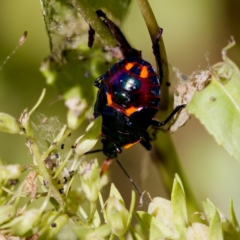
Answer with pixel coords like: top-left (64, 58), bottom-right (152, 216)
top-left (89, 10), bottom-right (185, 159)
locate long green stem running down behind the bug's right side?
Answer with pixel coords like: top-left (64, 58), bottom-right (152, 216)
top-left (136, 0), bottom-right (199, 214)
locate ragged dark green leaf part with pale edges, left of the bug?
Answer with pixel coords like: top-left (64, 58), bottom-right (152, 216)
top-left (40, 48), bottom-right (105, 106)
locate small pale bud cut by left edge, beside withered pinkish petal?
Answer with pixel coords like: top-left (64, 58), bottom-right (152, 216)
top-left (0, 164), bottom-right (22, 184)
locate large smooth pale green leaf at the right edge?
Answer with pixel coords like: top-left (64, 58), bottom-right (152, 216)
top-left (187, 40), bottom-right (240, 162)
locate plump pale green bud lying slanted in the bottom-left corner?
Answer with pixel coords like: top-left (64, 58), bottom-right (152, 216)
top-left (0, 209), bottom-right (42, 237)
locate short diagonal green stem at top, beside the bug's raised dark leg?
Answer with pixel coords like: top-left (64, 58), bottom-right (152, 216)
top-left (71, 0), bottom-right (117, 47)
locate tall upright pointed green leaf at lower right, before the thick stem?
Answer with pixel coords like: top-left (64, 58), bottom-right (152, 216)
top-left (171, 175), bottom-right (188, 226)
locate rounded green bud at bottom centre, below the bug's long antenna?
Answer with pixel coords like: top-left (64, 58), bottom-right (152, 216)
top-left (106, 196), bottom-right (129, 237)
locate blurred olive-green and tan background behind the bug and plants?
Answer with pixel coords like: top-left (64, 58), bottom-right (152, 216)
top-left (0, 0), bottom-right (240, 218)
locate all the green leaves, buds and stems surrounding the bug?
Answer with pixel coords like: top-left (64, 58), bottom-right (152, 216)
top-left (0, 0), bottom-right (240, 240)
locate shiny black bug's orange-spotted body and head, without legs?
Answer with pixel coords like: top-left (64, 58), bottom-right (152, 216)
top-left (94, 58), bottom-right (160, 158)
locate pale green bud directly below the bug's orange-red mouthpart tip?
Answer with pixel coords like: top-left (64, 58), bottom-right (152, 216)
top-left (79, 159), bottom-right (100, 202)
